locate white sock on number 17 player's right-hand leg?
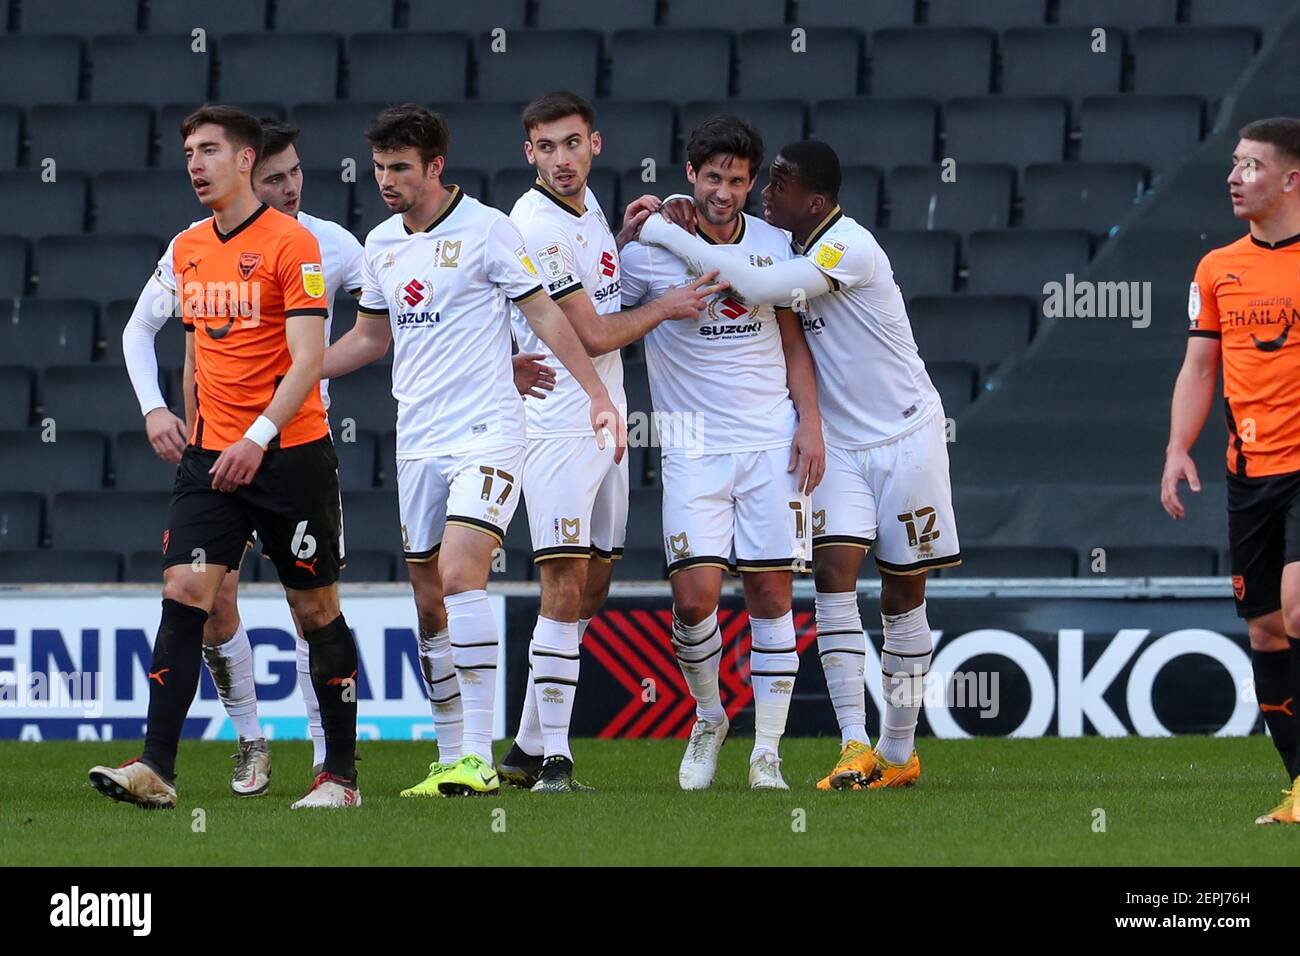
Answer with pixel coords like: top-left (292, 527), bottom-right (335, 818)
top-left (442, 588), bottom-right (501, 763)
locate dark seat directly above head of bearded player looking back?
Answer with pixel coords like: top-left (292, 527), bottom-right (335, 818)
top-left (475, 30), bottom-right (601, 103)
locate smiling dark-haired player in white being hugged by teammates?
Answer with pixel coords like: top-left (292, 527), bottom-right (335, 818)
top-left (623, 116), bottom-right (826, 790)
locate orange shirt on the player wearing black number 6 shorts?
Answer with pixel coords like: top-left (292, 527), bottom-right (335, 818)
top-left (173, 206), bottom-right (329, 451)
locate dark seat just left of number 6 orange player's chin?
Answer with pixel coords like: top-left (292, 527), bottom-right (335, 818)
top-left (95, 169), bottom-right (212, 239)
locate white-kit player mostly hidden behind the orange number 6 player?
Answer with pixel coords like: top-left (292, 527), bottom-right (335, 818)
top-left (122, 117), bottom-right (553, 796)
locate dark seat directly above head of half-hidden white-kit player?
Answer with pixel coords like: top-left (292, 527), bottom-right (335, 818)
top-left (217, 33), bottom-right (339, 103)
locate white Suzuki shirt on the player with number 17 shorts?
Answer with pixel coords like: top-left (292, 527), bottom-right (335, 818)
top-left (359, 186), bottom-right (545, 460)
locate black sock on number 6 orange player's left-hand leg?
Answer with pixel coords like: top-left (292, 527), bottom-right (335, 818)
top-left (142, 597), bottom-right (208, 780)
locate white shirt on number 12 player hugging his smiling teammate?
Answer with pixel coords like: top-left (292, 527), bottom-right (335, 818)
top-left (796, 206), bottom-right (940, 449)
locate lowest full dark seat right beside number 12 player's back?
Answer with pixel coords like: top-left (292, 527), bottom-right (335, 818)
top-left (907, 295), bottom-right (1034, 368)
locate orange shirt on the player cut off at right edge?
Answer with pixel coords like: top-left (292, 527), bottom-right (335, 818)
top-left (1187, 234), bottom-right (1300, 477)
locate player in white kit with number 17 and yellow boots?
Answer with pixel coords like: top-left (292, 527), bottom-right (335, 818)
top-left (325, 104), bottom-right (627, 796)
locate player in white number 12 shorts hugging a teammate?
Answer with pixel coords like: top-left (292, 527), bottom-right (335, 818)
top-left (641, 140), bottom-right (961, 790)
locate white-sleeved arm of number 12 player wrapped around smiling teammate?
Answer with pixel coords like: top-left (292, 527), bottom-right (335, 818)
top-left (641, 213), bottom-right (831, 306)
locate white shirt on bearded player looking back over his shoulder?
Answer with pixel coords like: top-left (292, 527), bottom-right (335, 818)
top-left (510, 182), bottom-right (625, 438)
